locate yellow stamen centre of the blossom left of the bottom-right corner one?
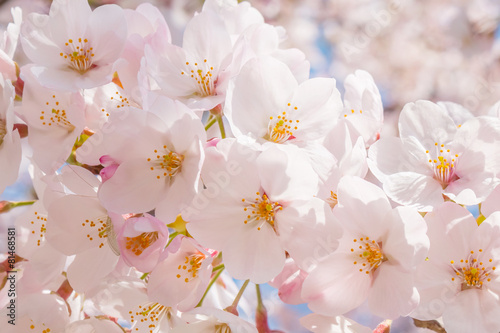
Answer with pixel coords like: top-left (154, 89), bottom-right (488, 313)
top-left (351, 237), bottom-right (387, 274)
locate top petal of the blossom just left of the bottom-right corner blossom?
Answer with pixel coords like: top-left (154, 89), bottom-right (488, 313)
top-left (334, 176), bottom-right (391, 239)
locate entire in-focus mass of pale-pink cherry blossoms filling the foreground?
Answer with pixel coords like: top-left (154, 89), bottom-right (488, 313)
top-left (0, 0), bottom-right (500, 333)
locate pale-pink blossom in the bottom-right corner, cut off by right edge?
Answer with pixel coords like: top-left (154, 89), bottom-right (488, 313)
top-left (411, 202), bottom-right (500, 332)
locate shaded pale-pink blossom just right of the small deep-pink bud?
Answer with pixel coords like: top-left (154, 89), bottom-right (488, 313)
top-left (94, 96), bottom-right (206, 223)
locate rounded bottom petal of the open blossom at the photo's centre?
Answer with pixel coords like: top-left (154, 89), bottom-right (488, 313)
top-left (222, 222), bottom-right (285, 284)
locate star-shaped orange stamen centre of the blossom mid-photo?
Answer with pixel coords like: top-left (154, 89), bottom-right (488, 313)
top-left (241, 192), bottom-right (283, 230)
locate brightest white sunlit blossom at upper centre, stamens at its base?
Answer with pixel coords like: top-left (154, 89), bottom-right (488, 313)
top-left (225, 57), bottom-right (342, 144)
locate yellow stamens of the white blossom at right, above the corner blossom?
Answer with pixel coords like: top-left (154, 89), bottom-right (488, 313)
top-left (425, 142), bottom-right (459, 189)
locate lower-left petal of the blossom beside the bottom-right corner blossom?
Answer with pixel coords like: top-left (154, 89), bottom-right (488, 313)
top-left (302, 254), bottom-right (372, 316)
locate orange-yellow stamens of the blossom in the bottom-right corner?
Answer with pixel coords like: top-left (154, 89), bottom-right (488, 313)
top-left (450, 249), bottom-right (496, 290)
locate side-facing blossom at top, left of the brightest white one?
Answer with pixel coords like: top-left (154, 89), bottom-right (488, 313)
top-left (145, 11), bottom-right (232, 110)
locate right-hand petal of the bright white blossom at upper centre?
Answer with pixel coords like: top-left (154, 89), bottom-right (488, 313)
top-left (291, 78), bottom-right (342, 140)
